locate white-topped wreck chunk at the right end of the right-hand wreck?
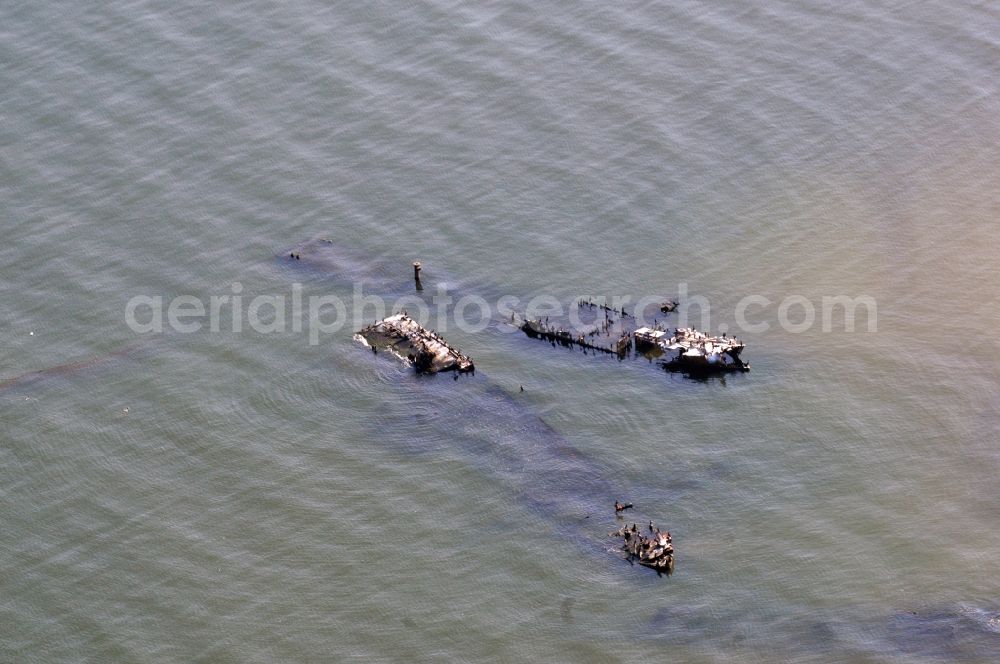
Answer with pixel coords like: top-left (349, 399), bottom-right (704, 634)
top-left (634, 327), bottom-right (750, 372)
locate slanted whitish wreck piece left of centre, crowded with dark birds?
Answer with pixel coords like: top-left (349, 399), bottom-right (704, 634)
top-left (357, 312), bottom-right (476, 373)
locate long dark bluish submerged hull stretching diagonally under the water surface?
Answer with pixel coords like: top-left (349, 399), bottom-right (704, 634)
top-left (278, 239), bottom-right (667, 571)
